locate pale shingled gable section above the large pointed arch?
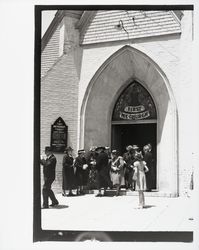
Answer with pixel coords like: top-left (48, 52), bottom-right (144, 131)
top-left (80, 10), bottom-right (181, 45)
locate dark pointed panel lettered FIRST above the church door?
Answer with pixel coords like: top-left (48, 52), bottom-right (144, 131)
top-left (112, 82), bottom-right (157, 121)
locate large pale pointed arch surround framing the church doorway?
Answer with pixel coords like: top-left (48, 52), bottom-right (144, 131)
top-left (80, 46), bottom-right (178, 196)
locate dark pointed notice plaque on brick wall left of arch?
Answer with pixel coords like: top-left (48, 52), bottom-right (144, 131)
top-left (51, 117), bottom-right (68, 153)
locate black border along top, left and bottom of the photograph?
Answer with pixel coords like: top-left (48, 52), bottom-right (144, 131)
top-left (33, 4), bottom-right (194, 242)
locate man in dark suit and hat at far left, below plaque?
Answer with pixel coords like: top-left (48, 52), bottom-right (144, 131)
top-left (40, 147), bottom-right (59, 208)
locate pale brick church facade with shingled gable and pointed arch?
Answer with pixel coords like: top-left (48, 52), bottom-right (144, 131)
top-left (40, 10), bottom-right (194, 197)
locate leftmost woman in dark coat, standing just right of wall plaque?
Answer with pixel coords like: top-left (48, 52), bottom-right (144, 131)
top-left (62, 147), bottom-right (76, 196)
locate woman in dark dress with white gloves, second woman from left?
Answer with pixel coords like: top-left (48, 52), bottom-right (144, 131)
top-left (74, 150), bottom-right (89, 195)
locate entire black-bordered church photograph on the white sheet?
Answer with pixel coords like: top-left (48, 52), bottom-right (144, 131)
top-left (34, 5), bottom-right (194, 242)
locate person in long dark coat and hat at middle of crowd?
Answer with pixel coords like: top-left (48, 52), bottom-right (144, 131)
top-left (96, 147), bottom-right (112, 197)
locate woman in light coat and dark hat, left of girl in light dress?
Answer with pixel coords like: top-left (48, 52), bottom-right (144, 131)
top-left (110, 150), bottom-right (125, 196)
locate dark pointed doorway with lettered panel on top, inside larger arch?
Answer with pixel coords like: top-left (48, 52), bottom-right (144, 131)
top-left (111, 81), bottom-right (157, 189)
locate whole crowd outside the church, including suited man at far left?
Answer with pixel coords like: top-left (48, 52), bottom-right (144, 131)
top-left (40, 143), bottom-right (154, 208)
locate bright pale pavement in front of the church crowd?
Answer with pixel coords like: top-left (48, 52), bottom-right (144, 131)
top-left (42, 190), bottom-right (194, 231)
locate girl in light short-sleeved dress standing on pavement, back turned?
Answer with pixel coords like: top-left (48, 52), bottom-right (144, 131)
top-left (133, 152), bottom-right (149, 208)
